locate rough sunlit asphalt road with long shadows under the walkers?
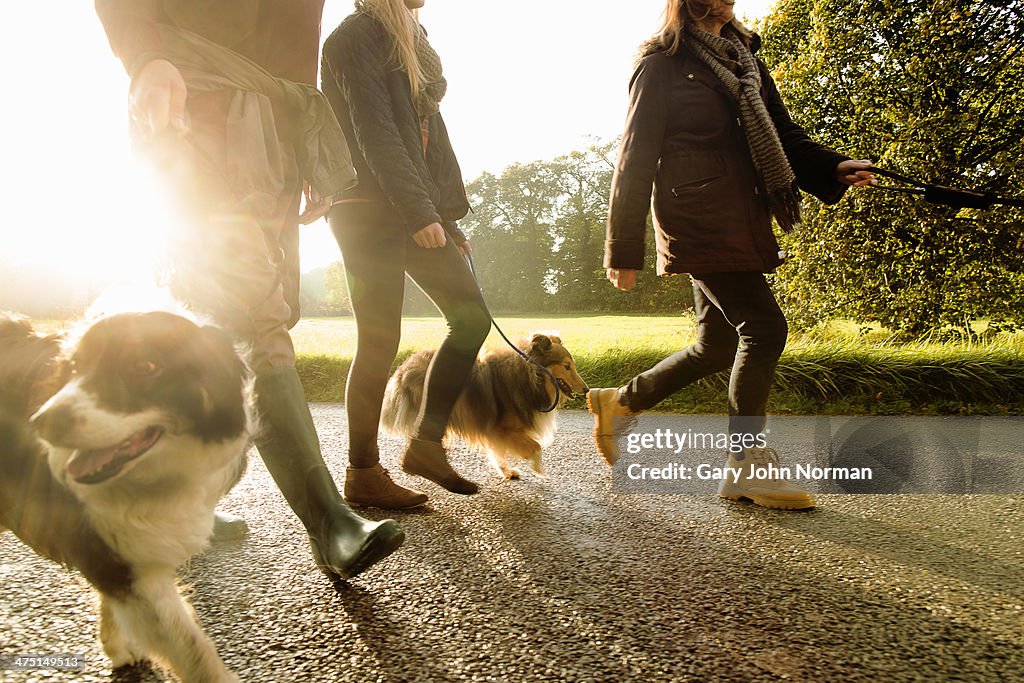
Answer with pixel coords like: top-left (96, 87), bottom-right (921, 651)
top-left (0, 404), bottom-right (1024, 683)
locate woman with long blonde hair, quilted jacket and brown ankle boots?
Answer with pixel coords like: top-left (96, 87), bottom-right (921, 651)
top-left (322, 0), bottom-right (490, 509)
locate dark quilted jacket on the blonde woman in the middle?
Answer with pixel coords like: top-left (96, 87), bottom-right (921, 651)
top-left (321, 12), bottom-right (469, 242)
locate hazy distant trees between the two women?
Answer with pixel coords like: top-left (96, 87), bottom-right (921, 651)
top-left (462, 142), bottom-right (692, 312)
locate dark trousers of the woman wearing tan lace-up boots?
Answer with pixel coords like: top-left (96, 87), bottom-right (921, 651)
top-left (624, 272), bottom-right (788, 435)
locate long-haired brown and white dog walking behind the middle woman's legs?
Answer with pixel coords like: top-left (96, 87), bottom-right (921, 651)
top-left (381, 334), bottom-right (588, 479)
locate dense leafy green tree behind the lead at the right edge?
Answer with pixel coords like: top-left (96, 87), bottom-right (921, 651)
top-left (759, 0), bottom-right (1024, 335)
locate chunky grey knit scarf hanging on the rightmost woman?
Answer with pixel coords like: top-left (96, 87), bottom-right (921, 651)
top-left (684, 25), bottom-right (800, 232)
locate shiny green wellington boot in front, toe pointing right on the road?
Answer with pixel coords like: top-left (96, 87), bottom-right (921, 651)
top-left (255, 367), bottom-right (406, 580)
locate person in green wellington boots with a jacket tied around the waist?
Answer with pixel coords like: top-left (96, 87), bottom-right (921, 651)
top-left (95, 0), bottom-right (404, 579)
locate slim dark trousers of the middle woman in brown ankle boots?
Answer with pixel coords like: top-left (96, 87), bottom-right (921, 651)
top-left (329, 202), bottom-right (490, 467)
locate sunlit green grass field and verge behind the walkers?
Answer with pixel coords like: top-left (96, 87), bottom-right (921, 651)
top-left (294, 314), bottom-right (1024, 415)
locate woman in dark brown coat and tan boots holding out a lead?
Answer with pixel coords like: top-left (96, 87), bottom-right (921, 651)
top-left (588, 0), bottom-right (874, 509)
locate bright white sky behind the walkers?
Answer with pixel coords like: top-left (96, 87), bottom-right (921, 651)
top-left (0, 0), bottom-right (774, 284)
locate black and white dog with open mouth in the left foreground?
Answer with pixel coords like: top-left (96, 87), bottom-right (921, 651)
top-left (0, 311), bottom-right (254, 682)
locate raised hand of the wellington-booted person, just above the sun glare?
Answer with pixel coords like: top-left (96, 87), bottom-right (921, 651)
top-left (128, 59), bottom-right (188, 136)
